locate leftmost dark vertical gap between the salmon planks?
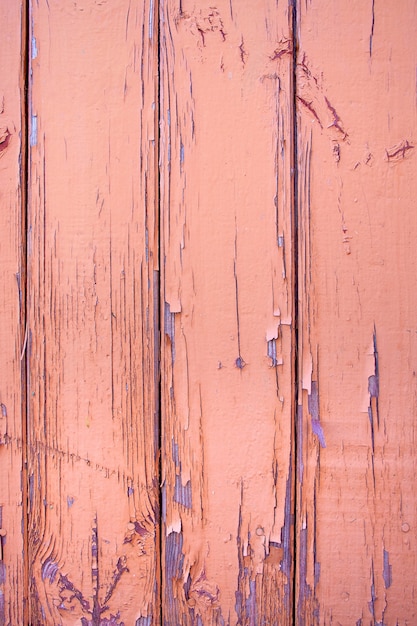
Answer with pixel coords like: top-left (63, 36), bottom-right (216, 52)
top-left (18, 0), bottom-right (30, 624)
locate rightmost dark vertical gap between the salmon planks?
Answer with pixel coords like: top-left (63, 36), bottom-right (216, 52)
top-left (289, 0), bottom-right (300, 626)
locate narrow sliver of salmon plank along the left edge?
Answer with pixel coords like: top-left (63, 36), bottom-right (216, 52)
top-left (0, 2), bottom-right (26, 626)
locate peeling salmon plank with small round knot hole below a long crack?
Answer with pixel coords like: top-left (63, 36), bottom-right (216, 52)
top-left (160, 0), bottom-right (294, 626)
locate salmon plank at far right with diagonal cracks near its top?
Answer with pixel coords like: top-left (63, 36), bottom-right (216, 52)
top-left (297, 0), bottom-right (417, 626)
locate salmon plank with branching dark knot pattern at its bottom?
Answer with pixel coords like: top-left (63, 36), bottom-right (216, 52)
top-left (28, 0), bottom-right (159, 626)
